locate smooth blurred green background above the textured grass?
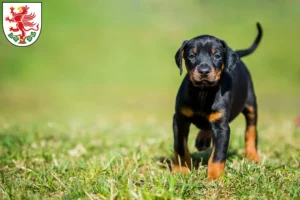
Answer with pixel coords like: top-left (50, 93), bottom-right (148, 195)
top-left (0, 0), bottom-right (300, 122)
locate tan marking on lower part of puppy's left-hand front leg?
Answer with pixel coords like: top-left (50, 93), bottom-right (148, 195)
top-left (172, 138), bottom-right (192, 174)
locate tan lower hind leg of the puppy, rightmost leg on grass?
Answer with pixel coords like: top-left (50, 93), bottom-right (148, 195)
top-left (245, 125), bottom-right (259, 162)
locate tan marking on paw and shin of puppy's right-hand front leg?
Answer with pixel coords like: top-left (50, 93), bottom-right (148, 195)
top-left (207, 147), bottom-right (225, 181)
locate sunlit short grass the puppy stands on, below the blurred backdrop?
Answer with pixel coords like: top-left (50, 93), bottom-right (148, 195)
top-left (0, 118), bottom-right (300, 199)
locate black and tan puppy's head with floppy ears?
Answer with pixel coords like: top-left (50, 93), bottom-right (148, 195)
top-left (175, 35), bottom-right (239, 87)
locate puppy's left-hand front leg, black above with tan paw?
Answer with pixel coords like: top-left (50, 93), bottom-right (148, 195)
top-left (172, 114), bottom-right (192, 173)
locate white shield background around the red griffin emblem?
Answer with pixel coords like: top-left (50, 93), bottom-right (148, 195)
top-left (2, 3), bottom-right (42, 46)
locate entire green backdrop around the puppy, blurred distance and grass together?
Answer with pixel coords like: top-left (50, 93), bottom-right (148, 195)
top-left (0, 0), bottom-right (300, 199)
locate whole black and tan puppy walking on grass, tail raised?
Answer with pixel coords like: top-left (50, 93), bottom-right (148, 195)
top-left (172, 23), bottom-right (262, 180)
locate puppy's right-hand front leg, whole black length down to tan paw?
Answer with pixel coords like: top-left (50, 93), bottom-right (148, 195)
top-left (207, 113), bottom-right (230, 180)
